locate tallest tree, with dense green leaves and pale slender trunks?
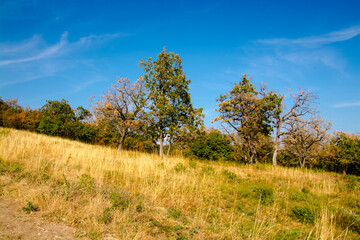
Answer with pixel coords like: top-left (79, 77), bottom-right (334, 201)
top-left (140, 48), bottom-right (202, 156)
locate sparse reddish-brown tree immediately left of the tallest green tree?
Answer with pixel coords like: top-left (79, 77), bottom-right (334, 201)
top-left (93, 78), bottom-right (147, 151)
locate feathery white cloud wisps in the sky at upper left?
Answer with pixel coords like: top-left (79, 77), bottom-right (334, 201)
top-left (0, 32), bottom-right (127, 93)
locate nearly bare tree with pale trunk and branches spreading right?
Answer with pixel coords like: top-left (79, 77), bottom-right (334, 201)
top-left (273, 90), bottom-right (316, 167)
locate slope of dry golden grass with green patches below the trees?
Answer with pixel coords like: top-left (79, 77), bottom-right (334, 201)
top-left (0, 128), bottom-right (360, 239)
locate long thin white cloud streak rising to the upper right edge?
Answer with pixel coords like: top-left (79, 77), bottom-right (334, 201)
top-left (257, 26), bottom-right (360, 47)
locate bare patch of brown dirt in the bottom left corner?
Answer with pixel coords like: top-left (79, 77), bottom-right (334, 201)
top-left (0, 197), bottom-right (77, 240)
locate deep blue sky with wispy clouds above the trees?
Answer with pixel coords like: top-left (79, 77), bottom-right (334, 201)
top-left (0, 0), bottom-right (360, 132)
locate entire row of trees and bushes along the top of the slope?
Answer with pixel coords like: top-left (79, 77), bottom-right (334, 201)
top-left (0, 48), bottom-right (360, 175)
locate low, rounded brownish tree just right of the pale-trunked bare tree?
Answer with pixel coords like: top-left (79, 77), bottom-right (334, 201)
top-left (284, 115), bottom-right (330, 168)
